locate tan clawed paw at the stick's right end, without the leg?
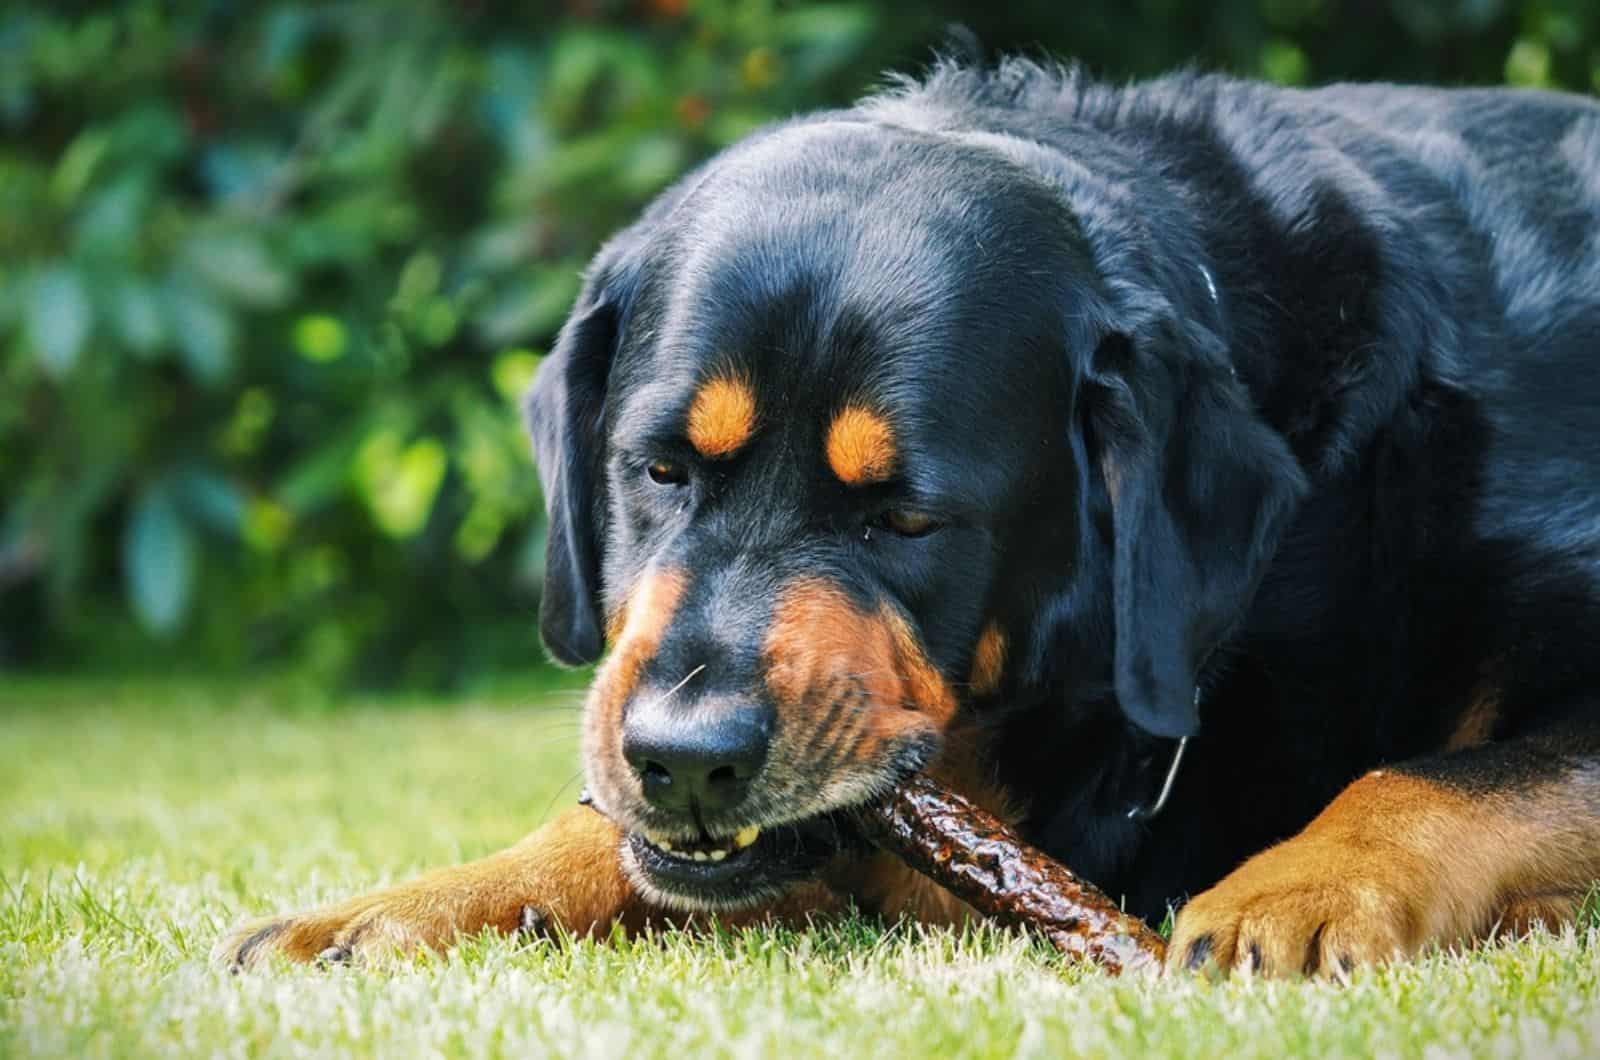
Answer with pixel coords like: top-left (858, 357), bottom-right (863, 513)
top-left (1166, 836), bottom-right (1434, 978)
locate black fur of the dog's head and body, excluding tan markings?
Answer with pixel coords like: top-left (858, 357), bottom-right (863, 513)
top-left (530, 61), bottom-right (1600, 916)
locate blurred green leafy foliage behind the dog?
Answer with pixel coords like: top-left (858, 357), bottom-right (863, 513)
top-left (0, 0), bottom-right (1600, 684)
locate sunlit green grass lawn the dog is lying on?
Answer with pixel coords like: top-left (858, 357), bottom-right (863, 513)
top-left (0, 679), bottom-right (1600, 1060)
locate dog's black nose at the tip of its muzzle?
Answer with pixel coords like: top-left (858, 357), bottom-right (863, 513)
top-left (622, 705), bottom-right (771, 813)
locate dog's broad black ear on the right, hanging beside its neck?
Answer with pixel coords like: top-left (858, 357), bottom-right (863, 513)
top-left (1086, 317), bottom-right (1306, 738)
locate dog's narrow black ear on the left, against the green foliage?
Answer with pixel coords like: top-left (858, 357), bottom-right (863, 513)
top-left (523, 231), bottom-right (642, 666)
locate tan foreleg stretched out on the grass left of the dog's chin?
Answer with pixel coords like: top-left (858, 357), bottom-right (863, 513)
top-left (213, 807), bottom-right (646, 969)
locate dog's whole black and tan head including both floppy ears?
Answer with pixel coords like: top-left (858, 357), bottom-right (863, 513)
top-left (528, 118), bottom-right (1298, 908)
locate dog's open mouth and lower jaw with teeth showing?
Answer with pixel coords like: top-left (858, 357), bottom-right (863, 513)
top-left (622, 810), bottom-right (858, 909)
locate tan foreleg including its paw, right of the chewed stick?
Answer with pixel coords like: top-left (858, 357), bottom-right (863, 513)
top-left (1168, 770), bottom-right (1600, 975)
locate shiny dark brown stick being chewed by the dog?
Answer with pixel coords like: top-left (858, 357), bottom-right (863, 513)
top-left (862, 777), bottom-right (1166, 975)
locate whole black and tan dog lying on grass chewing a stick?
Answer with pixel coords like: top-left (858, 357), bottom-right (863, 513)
top-left (218, 61), bottom-right (1600, 974)
